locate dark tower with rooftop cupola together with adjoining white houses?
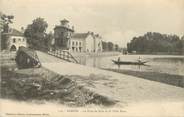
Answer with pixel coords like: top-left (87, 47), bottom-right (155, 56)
top-left (54, 19), bottom-right (102, 52)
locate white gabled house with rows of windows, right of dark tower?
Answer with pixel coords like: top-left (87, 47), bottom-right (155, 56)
top-left (68, 32), bottom-right (102, 52)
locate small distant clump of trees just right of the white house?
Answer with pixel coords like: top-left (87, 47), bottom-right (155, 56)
top-left (102, 41), bottom-right (121, 51)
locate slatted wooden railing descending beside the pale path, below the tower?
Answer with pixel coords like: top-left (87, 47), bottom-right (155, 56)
top-left (48, 50), bottom-right (79, 63)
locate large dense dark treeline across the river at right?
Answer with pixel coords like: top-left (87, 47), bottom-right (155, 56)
top-left (127, 32), bottom-right (184, 54)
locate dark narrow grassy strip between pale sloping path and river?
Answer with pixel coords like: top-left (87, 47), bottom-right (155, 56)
top-left (105, 69), bottom-right (184, 87)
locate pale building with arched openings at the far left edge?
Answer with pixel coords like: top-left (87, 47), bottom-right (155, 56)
top-left (1, 28), bottom-right (27, 51)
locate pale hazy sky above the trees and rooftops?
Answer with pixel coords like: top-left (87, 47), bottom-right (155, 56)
top-left (0, 0), bottom-right (184, 47)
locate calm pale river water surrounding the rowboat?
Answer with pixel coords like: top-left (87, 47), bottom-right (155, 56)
top-left (79, 55), bottom-right (184, 76)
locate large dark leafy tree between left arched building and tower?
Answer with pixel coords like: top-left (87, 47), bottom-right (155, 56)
top-left (24, 17), bottom-right (48, 50)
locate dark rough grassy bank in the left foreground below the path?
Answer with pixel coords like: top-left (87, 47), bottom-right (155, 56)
top-left (1, 67), bottom-right (115, 106)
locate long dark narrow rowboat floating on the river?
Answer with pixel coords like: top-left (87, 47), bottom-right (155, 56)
top-left (112, 60), bottom-right (148, 65)
